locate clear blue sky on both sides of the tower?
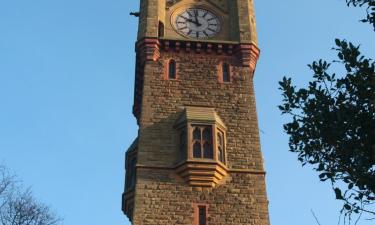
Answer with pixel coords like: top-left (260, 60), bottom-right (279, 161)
top-left (0, 0), bottom-right (375, 225)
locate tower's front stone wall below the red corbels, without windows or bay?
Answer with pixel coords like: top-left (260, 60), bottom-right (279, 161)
top-left (134, 51), bottom-right (269, 225)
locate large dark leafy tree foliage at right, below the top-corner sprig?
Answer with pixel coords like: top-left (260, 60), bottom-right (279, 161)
top-left (279, 39), bottom-right (375, 223)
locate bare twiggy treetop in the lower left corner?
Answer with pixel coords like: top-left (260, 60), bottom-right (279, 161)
top-left (0, 165), bottom-right (62, 225)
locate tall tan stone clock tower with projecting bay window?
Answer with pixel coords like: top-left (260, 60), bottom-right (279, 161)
top-left (122, 0), bottom-right (269, 225)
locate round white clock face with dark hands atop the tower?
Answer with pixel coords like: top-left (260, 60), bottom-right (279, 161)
top-left (174, 8), bottom-right (221, 39)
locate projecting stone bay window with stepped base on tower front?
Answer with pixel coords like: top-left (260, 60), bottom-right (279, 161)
top-left (172, 106), bottom-right (230, 187)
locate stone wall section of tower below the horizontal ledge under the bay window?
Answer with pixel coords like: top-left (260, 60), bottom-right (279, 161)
top-left (133, 169), bottom-right (269, 225)
